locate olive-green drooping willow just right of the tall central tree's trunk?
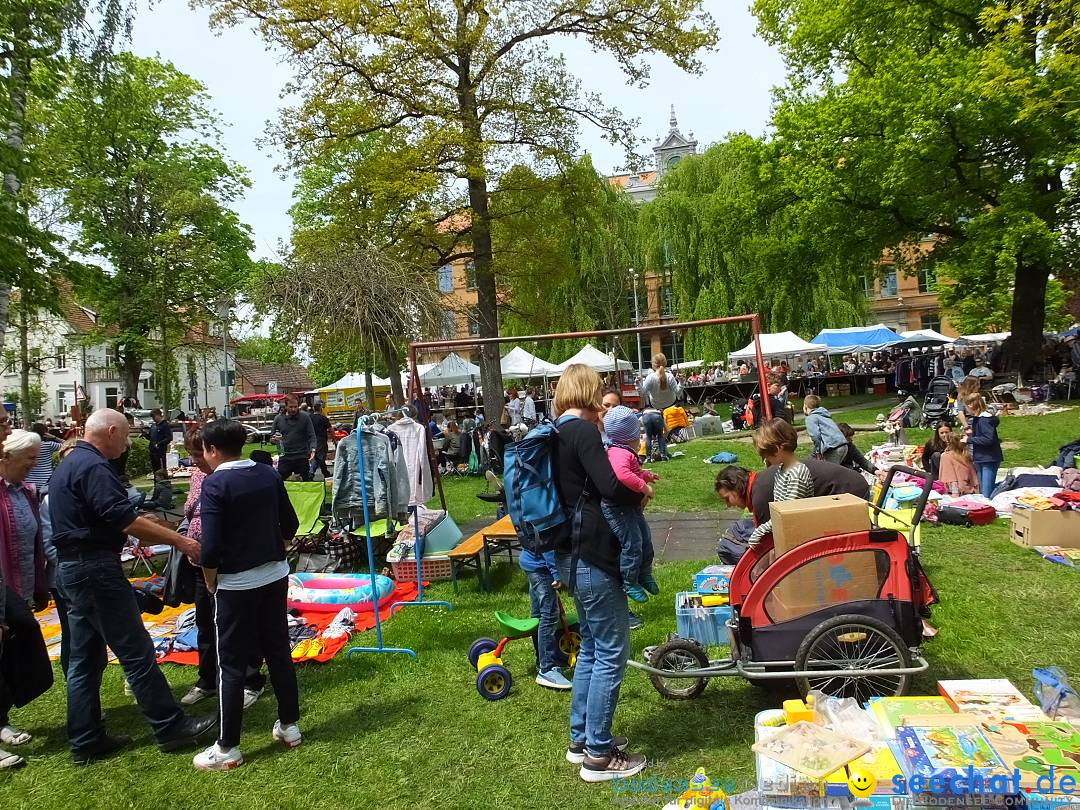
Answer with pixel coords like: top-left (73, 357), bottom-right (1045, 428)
top-left (491, 158), bottom-right (640, 357)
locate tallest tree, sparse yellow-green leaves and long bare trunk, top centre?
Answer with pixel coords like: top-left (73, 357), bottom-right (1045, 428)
top-left (200, 0), bottom-right (716, 419)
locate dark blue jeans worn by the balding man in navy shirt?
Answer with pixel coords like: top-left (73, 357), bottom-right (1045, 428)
top-left (57, 551), bottom-right (185, 752)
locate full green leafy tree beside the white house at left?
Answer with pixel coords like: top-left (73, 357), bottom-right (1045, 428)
top-left (43, 53), bottom-right (252, 406)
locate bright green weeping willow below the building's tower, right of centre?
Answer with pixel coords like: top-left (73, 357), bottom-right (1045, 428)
top-left (640, 135), bottom-right (880, 360)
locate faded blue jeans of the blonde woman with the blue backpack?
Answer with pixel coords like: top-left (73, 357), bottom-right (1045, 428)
top-left (556, 554), bottom-right (630, 757)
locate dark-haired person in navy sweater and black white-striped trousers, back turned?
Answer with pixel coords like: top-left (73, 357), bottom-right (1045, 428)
top-left (193, 419), bottom-right (302, 770)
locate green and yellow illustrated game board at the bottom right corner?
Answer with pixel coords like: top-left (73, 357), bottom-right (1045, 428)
top-left (981, 719), bottom-right (1080, 789)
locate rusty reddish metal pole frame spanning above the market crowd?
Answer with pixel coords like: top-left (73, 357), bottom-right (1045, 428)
top-left (408, 312), bottom-right (772, 509)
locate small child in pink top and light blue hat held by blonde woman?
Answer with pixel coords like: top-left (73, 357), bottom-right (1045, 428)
top-left (600, 405), bottom-right (660, 602)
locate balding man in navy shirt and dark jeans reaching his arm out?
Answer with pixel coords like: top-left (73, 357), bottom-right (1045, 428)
top-left (49, 408), bottom-right (217, 765)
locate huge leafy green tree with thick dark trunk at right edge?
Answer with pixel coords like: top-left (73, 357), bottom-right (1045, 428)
top-left (755, 0), bottom-right (1080, 376)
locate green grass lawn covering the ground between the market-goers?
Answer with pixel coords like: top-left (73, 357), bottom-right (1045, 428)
top-left (10, 410), bottom-right (1080, 810)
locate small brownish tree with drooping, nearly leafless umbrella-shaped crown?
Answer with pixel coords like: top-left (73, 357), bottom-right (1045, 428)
top-left (254, 238), bottom-right (443, 404)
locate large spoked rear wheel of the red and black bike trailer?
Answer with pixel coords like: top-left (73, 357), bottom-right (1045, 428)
top-left (795, 613), bottom-right (912, 705)
